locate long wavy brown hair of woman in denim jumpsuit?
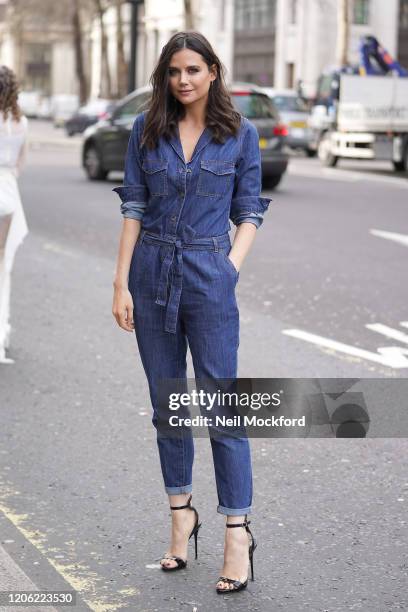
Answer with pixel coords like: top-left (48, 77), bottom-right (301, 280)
top-left (141, 32), bottom-right (241, 149)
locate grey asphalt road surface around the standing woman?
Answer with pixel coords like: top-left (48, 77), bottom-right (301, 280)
top-left (0, 123), bottom-right (408, 612)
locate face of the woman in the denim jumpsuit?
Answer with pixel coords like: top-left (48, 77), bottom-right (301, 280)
top-left (169, 49), bottom-right (216, 104)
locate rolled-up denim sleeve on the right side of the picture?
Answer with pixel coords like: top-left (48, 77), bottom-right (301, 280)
top-left (230, 119), bottom-right (272, 228)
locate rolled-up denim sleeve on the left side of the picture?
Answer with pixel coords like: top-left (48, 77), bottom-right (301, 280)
top-left (112, 114), bottom-right (148, 221)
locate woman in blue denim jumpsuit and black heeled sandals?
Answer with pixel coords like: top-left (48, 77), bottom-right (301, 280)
top-left (112, 32), bottom-right (269, 593)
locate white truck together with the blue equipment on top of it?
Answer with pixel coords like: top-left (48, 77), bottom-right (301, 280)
top-left (309, 36), bottom-right (408, 171)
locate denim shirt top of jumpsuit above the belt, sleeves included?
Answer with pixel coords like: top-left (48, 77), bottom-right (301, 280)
top-left (113, 113), bottom-right (271, 237)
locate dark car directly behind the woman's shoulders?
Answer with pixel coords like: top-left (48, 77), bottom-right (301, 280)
top-left (82, 83), bottom-right (288, 189)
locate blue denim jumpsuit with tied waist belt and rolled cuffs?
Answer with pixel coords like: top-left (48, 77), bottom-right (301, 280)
top-left (114, 113), bottom-right (270, 515)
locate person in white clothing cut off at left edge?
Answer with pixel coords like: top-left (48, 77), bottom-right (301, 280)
top-left (0, 66), bottom-right (27, 363)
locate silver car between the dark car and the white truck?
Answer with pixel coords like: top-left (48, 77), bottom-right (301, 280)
top-left (263, 87), bottom-right (316, 157)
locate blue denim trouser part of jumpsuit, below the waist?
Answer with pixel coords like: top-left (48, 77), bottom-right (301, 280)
top-left (129, 230), bottom-right (252, 515)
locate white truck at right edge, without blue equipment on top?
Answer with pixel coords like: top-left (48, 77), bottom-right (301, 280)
top-left (310, 74), bottom-right (408, 171)
